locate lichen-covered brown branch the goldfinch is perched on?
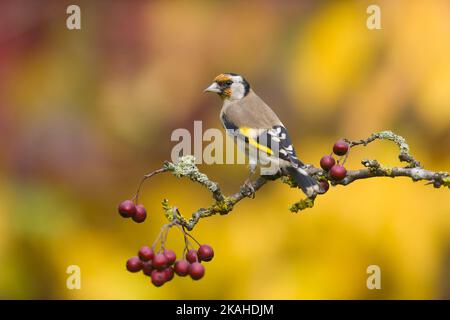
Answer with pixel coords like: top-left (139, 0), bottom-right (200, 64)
top-left (134, 131), bottom-right (450, 230)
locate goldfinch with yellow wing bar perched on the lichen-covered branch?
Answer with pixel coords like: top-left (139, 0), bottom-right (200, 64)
top-left (204, 73), bottom-right (323, 198)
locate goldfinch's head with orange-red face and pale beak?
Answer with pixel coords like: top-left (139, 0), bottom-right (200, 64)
top-left (204, 73), bottom-right (250, 100)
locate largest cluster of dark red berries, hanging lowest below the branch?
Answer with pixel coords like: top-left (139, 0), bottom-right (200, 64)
top-left (127, 244), bottom-right (214, 287)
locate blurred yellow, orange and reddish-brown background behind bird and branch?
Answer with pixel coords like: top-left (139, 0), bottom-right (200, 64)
top-left (0, 0), bottom-right (450, 299)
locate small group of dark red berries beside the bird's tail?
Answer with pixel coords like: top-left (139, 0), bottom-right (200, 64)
top-left (320, 140), bottom-right (350, 192)
